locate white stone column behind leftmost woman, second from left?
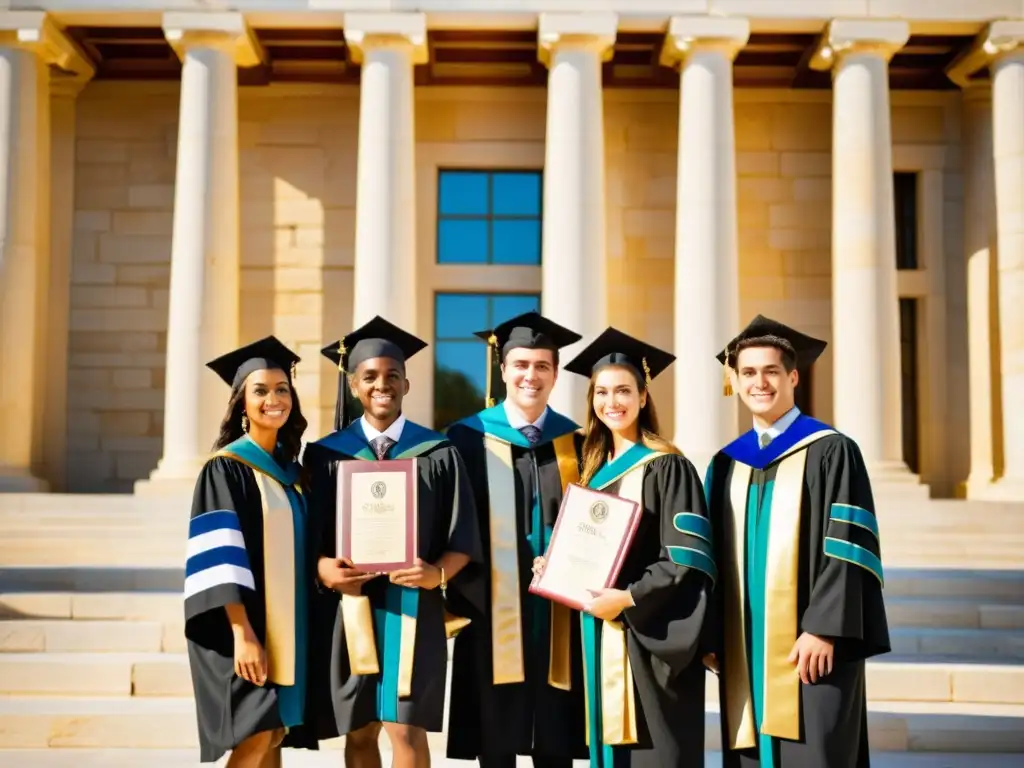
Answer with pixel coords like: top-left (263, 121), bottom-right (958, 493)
top-left (136, 12), bottom-right (261, 493)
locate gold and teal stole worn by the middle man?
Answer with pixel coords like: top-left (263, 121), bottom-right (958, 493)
top-left (458, 403), bottom-right (580, 690)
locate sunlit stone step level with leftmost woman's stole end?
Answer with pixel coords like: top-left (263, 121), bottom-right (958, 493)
top-left (8, 652), bottom-right (1024, 706)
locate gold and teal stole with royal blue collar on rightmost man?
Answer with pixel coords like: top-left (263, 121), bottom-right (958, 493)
top-left (706, 416), bottom-right (836, 757)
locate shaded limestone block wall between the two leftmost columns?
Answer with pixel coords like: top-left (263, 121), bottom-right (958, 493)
top-left (68, 82), bottom-right (178, 492)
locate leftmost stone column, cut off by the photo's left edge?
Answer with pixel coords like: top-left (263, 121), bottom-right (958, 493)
top-left (0, 11), bottom-right (91, 492)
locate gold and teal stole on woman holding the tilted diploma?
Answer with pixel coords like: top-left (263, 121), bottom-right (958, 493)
top-left (581, 443), bottom-right (666, 768)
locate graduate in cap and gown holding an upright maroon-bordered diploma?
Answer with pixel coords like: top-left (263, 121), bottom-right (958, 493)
top-left (304, 316), bottom-right (481, 768)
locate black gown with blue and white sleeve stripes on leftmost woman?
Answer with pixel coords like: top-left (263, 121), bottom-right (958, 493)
top-left (184, 436), bottom-right (316, 763)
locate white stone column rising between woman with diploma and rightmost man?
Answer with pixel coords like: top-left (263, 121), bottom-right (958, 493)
top-left (662, 16), bottom-right (751, 473)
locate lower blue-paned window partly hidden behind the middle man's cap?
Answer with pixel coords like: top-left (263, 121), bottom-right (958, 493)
top-left (434, 293), bottom-right (541, 429)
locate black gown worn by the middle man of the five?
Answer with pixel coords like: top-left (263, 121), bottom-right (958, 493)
top-left (447, 404), bottom-right (587, 762)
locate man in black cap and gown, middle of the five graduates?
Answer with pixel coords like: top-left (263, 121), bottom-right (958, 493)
top-left (447, 312), bottom-right (587, 768)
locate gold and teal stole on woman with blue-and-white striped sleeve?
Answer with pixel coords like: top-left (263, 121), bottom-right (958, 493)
top-left (215, 435), bottom-right (306, 700)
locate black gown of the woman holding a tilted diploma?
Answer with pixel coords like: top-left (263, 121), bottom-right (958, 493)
top-left (583, 444), bottom-right (716, 768)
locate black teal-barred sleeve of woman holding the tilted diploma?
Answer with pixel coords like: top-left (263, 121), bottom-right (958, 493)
top-left (624, 455), bottom-right (715, 676)
